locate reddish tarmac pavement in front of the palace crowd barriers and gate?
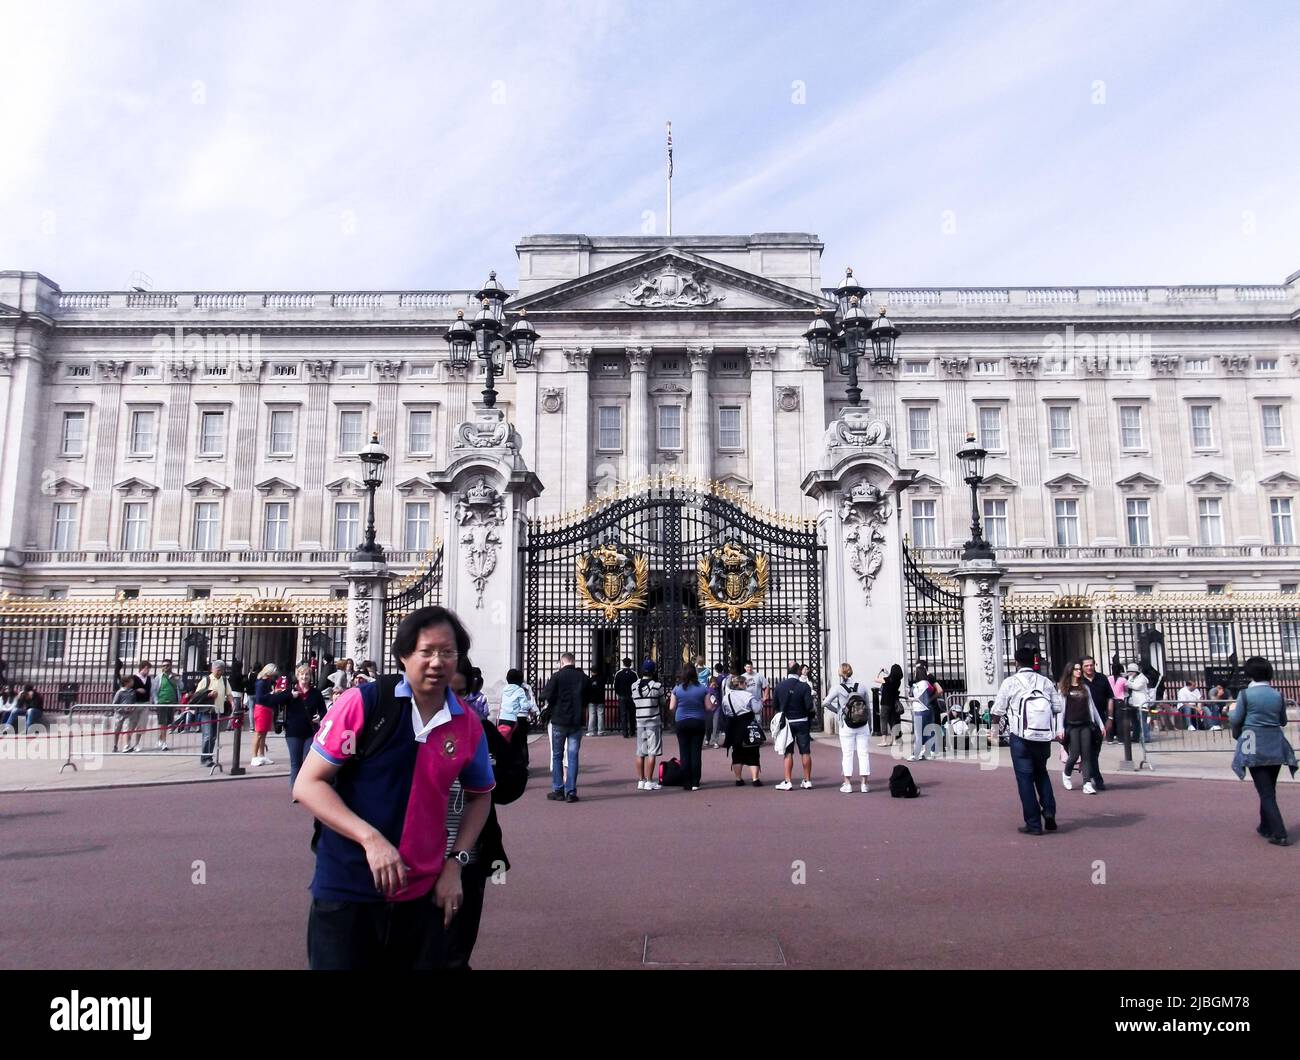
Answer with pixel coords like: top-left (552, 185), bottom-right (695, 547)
top-left (0, 735), bottom-right (1300, 969)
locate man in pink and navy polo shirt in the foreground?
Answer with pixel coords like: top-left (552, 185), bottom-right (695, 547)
top-left (294, 607), bottom-right (495, 970)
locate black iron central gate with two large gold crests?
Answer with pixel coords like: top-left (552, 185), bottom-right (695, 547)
top-left (521, 476), bottom-right (824, 688)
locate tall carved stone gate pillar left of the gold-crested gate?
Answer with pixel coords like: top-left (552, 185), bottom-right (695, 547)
top-left (430, 408), bottom-right (542, 705)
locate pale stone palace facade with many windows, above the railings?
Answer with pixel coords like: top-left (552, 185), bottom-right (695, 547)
top-left (0, 233), bottom-right (1300, 613)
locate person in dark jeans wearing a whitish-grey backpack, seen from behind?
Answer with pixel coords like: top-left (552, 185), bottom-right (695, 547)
top-left (993, 648), bottom-right (1065, 835)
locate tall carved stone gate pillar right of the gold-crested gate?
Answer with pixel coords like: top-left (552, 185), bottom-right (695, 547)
top-left (802, 407), bottom-right (917, 682)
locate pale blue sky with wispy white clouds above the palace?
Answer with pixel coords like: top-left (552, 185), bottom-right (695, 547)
top-left (0, 0), bottom-right (1300, 290)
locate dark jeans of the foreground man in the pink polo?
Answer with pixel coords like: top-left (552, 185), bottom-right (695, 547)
top-left (307, 892), bottom-right (447, 972)
